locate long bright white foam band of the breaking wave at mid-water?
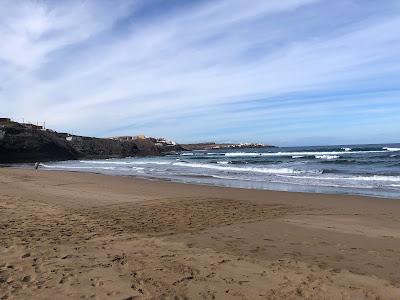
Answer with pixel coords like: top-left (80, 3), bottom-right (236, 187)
top-left (173, 162), bottom-right (302, 174)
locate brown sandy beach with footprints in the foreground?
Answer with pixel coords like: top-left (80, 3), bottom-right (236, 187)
top-left (0, 168), bottom-right (400, 299)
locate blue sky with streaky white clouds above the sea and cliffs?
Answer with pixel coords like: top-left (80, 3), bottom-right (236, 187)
top-left (0, 0), bottom-right (400, 146)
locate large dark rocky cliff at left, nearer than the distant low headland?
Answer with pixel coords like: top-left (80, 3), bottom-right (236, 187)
top-left (0, 122), bottom-right (182, 163)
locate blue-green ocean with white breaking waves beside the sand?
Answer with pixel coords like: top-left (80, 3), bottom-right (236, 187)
top-left (41, 144), bottom-right (400, 199)
